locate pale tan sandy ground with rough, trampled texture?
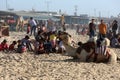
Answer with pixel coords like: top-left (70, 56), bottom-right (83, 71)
top-left (0, 30), bottom-right (120, 80)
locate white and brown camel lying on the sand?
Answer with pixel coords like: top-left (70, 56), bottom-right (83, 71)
top-left (62, 34), bottom-right (117, 63)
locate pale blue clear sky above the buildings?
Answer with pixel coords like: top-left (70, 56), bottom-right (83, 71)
top-left (0, 0), bottom-right (120, 17)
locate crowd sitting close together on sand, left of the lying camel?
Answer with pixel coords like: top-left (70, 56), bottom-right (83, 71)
top-left (0, 22), bottom-right (66, 54)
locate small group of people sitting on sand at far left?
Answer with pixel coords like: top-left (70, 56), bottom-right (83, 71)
top-left (0, 36), bottom-right (32, 53)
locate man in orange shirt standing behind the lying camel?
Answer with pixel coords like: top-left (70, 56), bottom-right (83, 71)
top-left (98, 20), bottom-right (107, 39)
